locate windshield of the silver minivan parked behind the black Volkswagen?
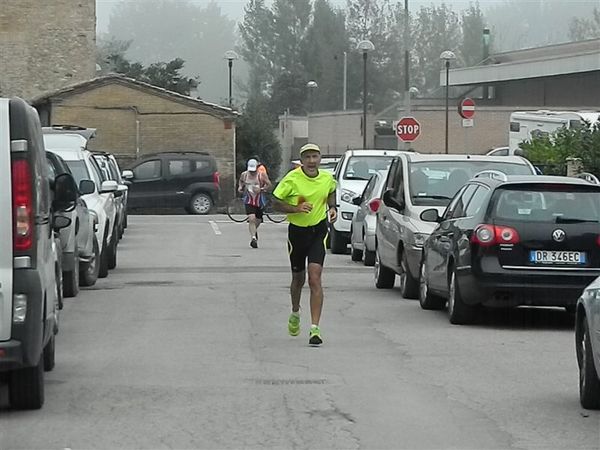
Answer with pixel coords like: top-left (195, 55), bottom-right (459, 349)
top-left (409, 160), bottom-right (533, 206)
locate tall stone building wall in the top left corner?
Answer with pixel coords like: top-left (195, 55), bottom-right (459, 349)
top-left (0, 0), bottom-right (96, 99)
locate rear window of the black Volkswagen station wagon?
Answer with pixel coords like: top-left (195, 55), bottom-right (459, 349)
top-left (492, 185), bottom-right (600, 223)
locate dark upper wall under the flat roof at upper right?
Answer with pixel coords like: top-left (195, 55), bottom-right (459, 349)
top-left (496, 72), bottom-right (600, 109)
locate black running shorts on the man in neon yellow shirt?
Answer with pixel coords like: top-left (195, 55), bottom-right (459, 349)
top-left (288, 220), bottom-right (328, 272)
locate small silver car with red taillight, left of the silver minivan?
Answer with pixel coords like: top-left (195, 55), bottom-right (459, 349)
top-left (350, 170), bottom-right (387, 266)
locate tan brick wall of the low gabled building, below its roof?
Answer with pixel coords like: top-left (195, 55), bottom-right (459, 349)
top-left (45, 83), bottom-right (235, 200)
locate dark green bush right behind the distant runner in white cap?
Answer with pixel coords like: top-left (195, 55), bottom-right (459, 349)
top-left (236, 95), bottom-right (281, 180)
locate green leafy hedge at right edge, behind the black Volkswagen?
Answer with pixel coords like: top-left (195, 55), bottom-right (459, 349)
top-left (521, 121), bottom-right (600, 176)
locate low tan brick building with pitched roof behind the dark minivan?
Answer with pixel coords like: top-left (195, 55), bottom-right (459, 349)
top-left (32, 74), bottom-right (238, 197)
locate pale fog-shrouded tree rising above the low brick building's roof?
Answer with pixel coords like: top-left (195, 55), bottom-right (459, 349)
top-left (108, 0), bottom-right (237, 101)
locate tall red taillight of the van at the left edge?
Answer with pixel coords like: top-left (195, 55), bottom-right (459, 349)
top-left (12, 159), bottom-right (33, 251)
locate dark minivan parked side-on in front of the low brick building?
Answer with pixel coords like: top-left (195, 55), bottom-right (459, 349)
top-left (123, 152), bottom-right (221, 214)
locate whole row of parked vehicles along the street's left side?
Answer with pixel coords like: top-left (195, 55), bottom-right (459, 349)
top-left (0, 103), bottom-right (127, 409)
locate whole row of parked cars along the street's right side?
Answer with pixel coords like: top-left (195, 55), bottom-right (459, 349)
top-left (332, 152), bottom-right (600, 409)
